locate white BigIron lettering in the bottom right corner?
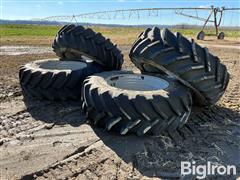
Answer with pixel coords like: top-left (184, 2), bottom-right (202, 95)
top-left (181, 161), bottom-right (237, 179)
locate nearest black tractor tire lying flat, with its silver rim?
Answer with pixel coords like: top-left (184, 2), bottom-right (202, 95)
top-left (82, 71), bottom-right (192, 135)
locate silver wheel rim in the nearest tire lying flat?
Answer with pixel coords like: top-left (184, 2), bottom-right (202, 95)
top-left (106, 74), bottom-right (169, 91)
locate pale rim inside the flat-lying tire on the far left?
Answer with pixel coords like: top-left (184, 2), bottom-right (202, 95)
top-left (38, 60), bottom-right (87, 71)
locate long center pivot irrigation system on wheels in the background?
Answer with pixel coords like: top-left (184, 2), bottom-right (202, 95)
top-left (41, 6), bottom-right (240, 40)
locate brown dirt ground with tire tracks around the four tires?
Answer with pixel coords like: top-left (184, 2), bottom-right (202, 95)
top-left (0, 35), bottom-right (240, 180)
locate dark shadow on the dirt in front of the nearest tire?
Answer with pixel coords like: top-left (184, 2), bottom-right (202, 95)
top-left (94, 106), bottom-right (240, 179)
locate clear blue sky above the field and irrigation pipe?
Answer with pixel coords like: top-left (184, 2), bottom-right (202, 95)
top-left (0, 0), bottom-right (240, 26)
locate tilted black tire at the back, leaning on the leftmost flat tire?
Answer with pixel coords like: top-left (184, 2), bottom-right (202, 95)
top-left (52, 25), bottom-right (123, 71)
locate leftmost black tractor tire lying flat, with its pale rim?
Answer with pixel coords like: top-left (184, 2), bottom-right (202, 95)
top-left (19, 59), bottom-right (102, 100)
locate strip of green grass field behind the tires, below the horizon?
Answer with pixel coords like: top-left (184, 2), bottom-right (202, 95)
top-left (0, 24), bottom-right (240, 37)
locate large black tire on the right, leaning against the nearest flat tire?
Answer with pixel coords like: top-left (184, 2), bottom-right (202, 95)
top-left (130, 27), bottom-right (229, 106)
